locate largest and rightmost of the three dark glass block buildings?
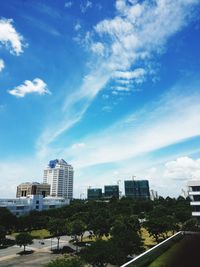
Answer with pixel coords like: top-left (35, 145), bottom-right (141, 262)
top-left (124, 180), bottom-right (150, 199)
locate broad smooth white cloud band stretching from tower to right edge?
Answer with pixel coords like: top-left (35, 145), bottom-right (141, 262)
top-left (59, 86), bottom-right (200, 170)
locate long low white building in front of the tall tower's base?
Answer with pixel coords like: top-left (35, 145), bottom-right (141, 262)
top-left (0, 195), bottom-right (70, 219)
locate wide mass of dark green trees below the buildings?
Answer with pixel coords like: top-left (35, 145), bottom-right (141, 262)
top-left (0, 197), bottom-right (194, 267)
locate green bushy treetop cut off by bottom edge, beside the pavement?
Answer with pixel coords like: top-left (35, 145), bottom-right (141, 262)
top-left (44, 256), bottom-right (85, 267)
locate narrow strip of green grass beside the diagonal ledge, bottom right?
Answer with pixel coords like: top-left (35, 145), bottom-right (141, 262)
top-left (148, 241), bottom-right (182, 267)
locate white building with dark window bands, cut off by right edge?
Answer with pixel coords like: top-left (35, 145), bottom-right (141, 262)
top-left (187, 180), bottom-right (200, 218)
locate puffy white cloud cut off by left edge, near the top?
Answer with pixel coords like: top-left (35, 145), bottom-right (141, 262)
top-left (0, 19), bottom-right (23, 56)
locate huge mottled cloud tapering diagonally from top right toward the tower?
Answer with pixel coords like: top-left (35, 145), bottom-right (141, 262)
top-left (38, 0), bottom-right (198, 155)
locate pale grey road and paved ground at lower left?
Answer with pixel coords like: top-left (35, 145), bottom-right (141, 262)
top-left (0, 236), bottom-right (76, 267)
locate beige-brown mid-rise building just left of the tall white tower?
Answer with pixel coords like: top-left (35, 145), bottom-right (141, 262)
top-left (16, 182), bottom-right (50, 198)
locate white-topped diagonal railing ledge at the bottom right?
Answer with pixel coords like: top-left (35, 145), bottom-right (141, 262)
top-left (121, 231), bottom-right (184, 267)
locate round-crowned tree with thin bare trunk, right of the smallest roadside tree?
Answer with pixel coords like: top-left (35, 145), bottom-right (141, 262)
top-left (47, 219), bottom-right (66, 249)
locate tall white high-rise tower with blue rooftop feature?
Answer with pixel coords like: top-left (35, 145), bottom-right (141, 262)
top-left (43, 159), bottom-right (74, 199)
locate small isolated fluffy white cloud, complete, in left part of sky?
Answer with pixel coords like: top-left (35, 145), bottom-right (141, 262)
top-left (8, 78), bottom-right (50, 97)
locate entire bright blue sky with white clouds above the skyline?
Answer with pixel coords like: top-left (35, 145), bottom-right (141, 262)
top-left (0, 0), bottom-right (200, 198)
